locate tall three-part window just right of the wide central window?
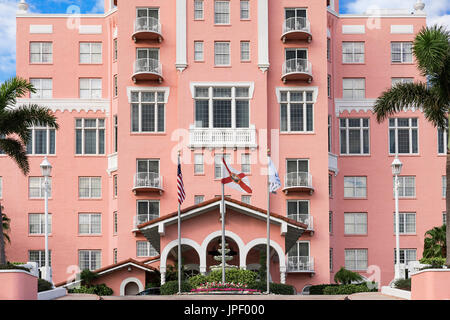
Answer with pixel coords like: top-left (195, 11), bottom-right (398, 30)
top-left (280, 91), bottom-right (314, 132)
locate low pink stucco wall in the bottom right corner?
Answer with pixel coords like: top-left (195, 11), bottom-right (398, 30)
top-left (411, 270), bottom-right (450, 300)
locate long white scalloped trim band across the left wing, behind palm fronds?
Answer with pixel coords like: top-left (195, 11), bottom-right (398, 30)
top-left (17, 98), bottom-right (110, 114)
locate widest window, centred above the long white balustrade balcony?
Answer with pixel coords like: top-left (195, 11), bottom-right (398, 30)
top-left (194, 87), bottom-right (250, 129)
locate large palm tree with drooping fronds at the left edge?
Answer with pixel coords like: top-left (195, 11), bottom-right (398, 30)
top-left (0, 77), bottom-right (58, 265)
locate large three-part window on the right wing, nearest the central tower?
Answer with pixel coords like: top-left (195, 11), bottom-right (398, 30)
top-left (339, 118), bottom-right (370, 154)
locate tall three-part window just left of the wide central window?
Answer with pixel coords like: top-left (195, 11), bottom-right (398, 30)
top-left (131, 91), bottom-right (166, 132)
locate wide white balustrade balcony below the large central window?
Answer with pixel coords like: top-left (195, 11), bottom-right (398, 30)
top-left (189, 125), bottom-right (257, 149)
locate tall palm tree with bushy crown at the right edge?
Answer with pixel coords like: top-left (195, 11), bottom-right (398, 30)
top-left (374, 25), bottom-right (450, 266)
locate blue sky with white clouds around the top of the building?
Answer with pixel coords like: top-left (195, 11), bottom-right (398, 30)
top-left (0, 0), bottom-right (450, 82)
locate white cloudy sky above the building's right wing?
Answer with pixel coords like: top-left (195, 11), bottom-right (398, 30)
top-left (344, 0), bottom-right (450, 29)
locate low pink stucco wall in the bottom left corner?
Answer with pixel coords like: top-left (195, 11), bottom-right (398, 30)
top-left (0, 270), bottom-right (37, 300)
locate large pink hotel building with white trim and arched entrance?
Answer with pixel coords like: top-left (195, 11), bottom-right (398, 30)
top-left (0, 0), bottom-right (446, 294)
